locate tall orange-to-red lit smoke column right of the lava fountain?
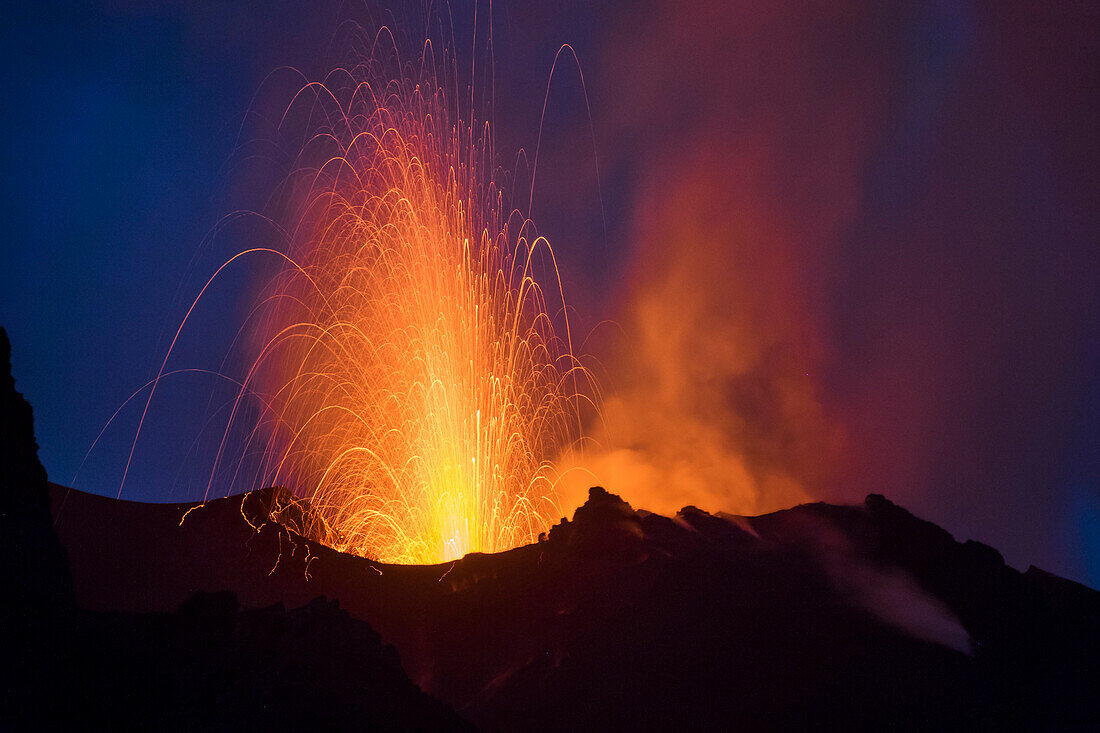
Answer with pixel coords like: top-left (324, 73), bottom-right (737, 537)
top-left (558, 3), bottom-right (876, 513)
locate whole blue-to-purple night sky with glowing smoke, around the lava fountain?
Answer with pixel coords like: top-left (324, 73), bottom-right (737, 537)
top-left (0, 0), bottom-right (1100, 587)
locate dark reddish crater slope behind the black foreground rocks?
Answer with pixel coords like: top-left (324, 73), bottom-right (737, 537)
top-left (45, 486), bottom-right (1100, 730)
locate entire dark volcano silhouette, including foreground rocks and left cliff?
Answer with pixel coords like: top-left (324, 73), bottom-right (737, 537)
top-left (3, 325), bottom-right (1100, 731)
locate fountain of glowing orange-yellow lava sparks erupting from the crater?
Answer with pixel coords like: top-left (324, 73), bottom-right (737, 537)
top-left (205, 55), bottom-right (584, 564)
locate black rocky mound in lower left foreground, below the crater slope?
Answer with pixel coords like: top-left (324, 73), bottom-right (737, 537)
top-left (76, 591), bottom-right (472, 731)
